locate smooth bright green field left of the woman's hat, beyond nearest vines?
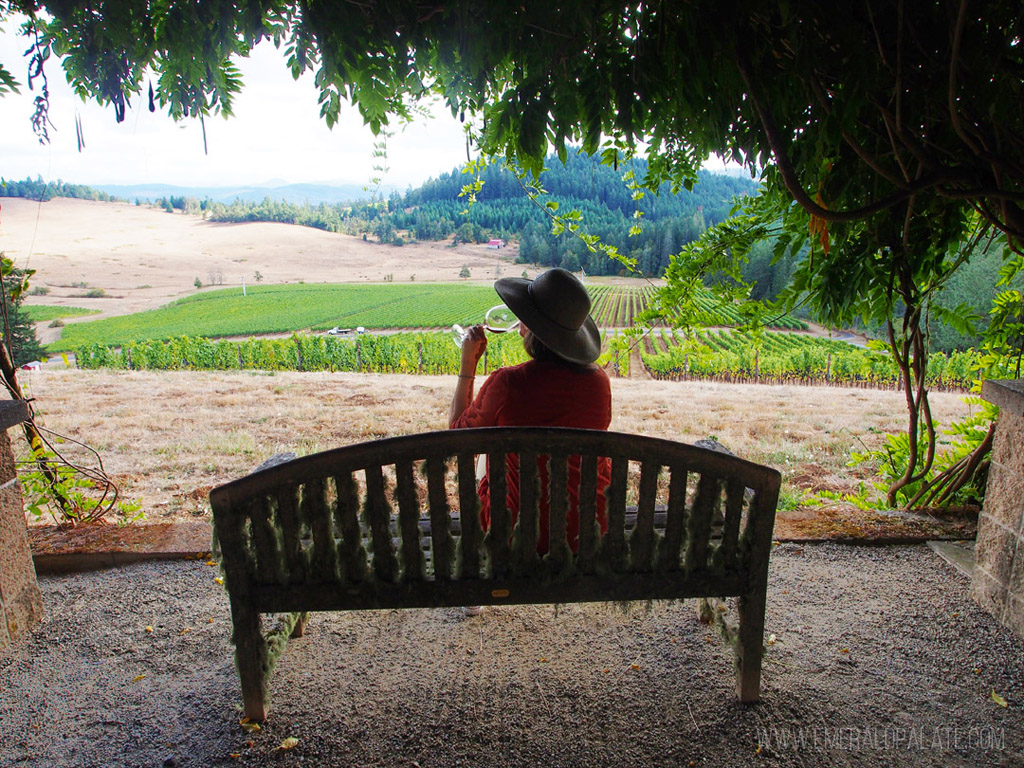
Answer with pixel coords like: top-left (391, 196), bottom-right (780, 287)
top-left (48, 283), bottom-right (500, 351)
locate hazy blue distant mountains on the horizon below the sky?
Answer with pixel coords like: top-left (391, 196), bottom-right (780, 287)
top-left (93, 184), bottom-right (396, 205)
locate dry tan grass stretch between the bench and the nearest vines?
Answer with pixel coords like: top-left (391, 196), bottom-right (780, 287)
top-left (18, 370), bottom-right (969, 522)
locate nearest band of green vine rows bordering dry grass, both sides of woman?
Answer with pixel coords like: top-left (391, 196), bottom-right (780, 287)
top-left (77, 331), bottom-right (978, 389)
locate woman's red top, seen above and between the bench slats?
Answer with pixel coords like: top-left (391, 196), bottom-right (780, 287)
top-left (453, 360), bottom-right (611, 554)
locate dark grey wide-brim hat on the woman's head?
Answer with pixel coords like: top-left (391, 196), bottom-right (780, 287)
top-left (495, 269), bottom-right (601, 365)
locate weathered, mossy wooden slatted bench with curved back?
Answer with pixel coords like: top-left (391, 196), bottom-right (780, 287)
top-left (210, 427), bottom-right (779, 721)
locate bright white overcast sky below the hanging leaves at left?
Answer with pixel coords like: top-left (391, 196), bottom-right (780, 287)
top-left (0, 27), bottom-right (466, 190)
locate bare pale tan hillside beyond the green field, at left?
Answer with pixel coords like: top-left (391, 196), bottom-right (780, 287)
top-left (0, 198), bottom-right (536, 319)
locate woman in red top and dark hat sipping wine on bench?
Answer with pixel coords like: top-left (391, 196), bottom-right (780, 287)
top-left (449, 269), bottom-right (611, 554)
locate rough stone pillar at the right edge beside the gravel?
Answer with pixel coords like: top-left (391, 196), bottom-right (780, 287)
top-left (971, 380), bottom-right (1024, 637)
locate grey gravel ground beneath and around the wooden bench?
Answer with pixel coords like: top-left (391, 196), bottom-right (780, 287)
top-left (0, 545), bottom-right (1024, 768)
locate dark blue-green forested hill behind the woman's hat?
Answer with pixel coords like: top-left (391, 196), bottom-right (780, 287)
top-left (203, 155), bottom-right (756, 275)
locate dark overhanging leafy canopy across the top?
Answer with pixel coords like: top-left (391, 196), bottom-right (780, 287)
top-left (0, 0), bottom-right (1024, 248)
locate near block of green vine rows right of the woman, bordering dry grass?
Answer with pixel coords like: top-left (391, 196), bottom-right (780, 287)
top-left (640, 330), bottom-right (979, 389)
